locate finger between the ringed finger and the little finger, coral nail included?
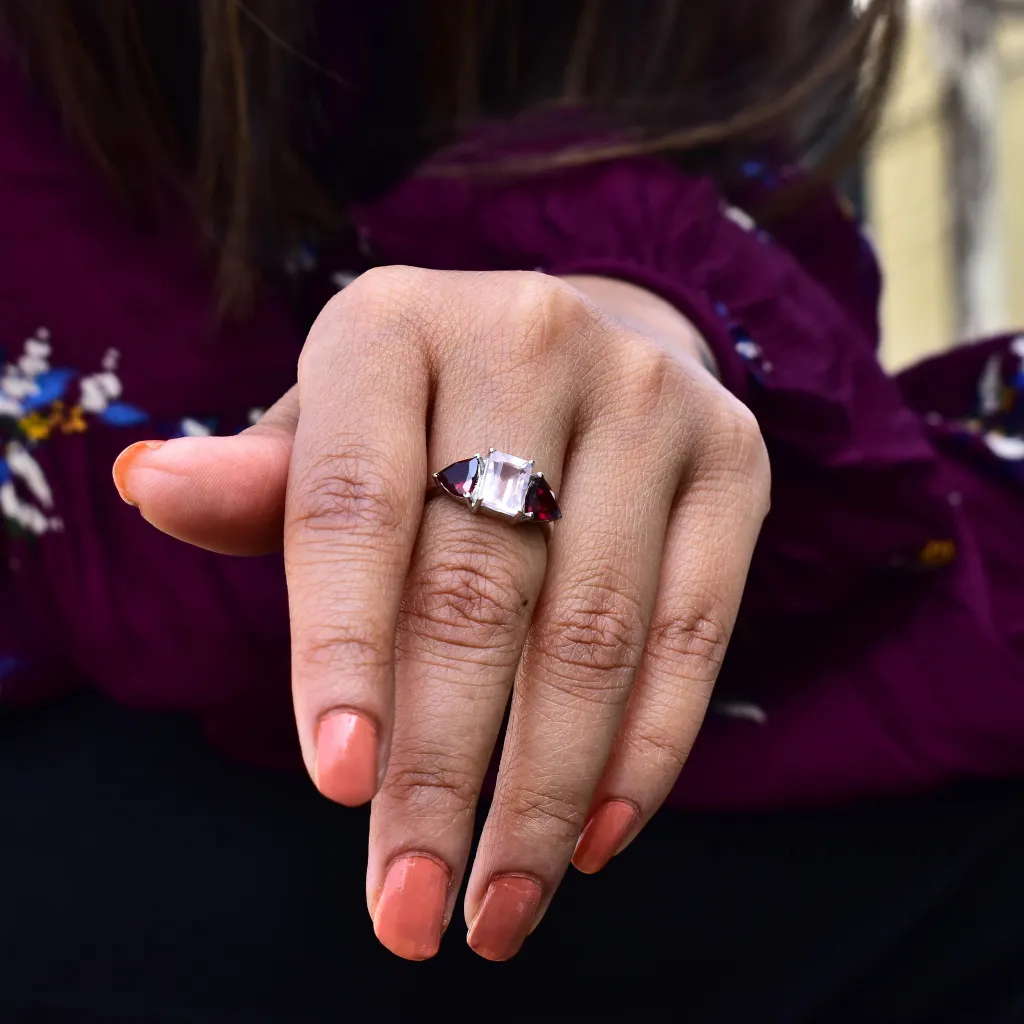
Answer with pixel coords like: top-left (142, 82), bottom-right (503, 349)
top-left (466, 352), bottom-right (680, 959)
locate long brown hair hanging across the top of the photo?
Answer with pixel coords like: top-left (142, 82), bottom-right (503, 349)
top-left (6, 0), bottom-right (904, 308)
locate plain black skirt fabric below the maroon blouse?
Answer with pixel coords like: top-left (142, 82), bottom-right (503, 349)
top-left (0, 696), bottom-right (1024, 1024)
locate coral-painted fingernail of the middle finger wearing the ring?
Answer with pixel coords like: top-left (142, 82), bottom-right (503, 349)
top-left (374, 855), bottom-right (450, 959)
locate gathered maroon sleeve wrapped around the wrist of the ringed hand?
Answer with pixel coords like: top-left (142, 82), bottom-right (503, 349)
top-left (356, 152), bottom-right (954, 615)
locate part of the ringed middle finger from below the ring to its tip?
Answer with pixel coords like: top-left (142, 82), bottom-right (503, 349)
top-left (367, 500), bottom-right (545, 959)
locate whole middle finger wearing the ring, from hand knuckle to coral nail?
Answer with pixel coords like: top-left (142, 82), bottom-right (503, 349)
top-left (367, 284), bottom-right (575, 959)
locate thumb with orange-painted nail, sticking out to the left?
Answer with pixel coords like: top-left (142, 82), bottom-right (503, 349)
top-left (114, 387), bottom-right (299, 555)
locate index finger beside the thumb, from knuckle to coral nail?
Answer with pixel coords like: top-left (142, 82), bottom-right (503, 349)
top-left (284, 268), bottom-right (429, 806)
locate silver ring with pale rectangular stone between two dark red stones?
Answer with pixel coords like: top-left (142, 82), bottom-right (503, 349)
top-left (434, 449), bottom-right (562, 523)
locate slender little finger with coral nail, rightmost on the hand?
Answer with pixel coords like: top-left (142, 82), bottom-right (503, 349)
top-left (572, 399), bottom-right (770, 873)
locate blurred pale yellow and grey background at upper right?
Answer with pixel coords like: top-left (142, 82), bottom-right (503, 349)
top-left (861, 0), bottom-right (1024, 369)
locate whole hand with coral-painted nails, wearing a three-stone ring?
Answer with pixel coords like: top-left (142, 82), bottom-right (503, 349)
top-left (117, 267), bottom-right (769, 959)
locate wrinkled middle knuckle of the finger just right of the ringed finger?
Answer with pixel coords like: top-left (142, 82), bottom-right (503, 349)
top-left (530, 583), bottom-right (644, 702)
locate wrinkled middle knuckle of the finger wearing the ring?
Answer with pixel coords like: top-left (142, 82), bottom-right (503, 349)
top-left (403, 550), bottom-right (528, 652)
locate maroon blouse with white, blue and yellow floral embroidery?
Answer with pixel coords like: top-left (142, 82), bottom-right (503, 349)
top-left (0, 54), bottom-right (1024, 807)
